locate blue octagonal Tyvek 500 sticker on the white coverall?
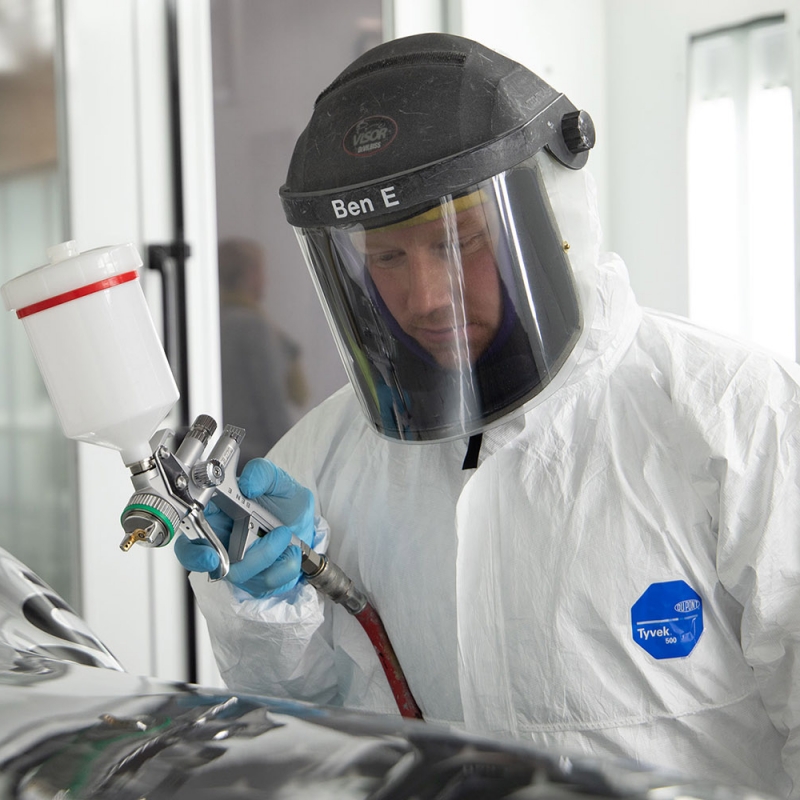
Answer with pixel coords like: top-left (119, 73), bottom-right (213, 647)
top-left (631, 581), bottom-right (703, 659)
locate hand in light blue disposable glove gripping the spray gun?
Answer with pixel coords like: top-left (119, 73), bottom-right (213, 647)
top-left (175, 458), bottom-right (314, 597)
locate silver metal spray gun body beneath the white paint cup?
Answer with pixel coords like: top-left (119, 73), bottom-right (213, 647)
top-left (120, 414), bottom-right (367, 615)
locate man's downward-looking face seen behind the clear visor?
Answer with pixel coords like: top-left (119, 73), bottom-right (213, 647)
top-left (356, 203), bottom-right (503, 369)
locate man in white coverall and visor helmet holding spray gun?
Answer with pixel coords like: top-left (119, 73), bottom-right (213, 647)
top-left (176, 34), bottom-right (800, 796)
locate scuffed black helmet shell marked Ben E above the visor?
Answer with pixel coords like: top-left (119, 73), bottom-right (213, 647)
top-left (280, 33), bottom-right (594, 227)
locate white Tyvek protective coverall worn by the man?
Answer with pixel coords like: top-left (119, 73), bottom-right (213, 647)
top-left (193, 183), bottom-right (800, 795)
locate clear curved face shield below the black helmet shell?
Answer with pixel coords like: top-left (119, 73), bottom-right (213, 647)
top-left (299, 160), bottom-right (582, 442)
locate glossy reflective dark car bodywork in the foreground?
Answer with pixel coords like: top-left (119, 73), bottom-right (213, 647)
top-left (0, 549), bottom-right (780, 800)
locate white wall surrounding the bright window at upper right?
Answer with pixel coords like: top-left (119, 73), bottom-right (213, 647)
top-left (606, 0), bottom-right (800, 315)
